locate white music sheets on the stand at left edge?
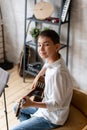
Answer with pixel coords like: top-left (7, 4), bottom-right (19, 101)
top-left (0, 68), bottom-right (10, 96)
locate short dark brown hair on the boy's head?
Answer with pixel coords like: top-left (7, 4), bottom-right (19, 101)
top-left (38, 29), bottom-right (60, 44)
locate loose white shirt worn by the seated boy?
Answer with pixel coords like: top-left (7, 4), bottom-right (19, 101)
top-left (34, 58), bottom-right (73, 125)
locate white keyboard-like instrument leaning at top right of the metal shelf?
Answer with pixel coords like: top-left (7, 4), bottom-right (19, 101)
top-left (61, 0), bottom-right (71, 22)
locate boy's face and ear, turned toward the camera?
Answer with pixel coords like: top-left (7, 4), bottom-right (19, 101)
top-left (38, 36), bottom-right (60, 61)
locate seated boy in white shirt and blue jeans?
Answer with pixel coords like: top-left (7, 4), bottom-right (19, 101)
top-left (11, 30), bottom-right (73, 130)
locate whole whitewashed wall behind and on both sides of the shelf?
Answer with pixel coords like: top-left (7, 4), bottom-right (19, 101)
top-left (1, 0), bottom-right (87, 91)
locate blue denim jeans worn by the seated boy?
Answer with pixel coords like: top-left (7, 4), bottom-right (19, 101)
top-left (11, 105), bottom-right (58, 130)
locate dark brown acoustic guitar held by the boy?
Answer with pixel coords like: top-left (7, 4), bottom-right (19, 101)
top-left (16, 76), bottom-right (45, 117)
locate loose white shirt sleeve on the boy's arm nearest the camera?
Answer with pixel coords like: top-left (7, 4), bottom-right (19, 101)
top-left (45, 72), bottom-right (72, 111)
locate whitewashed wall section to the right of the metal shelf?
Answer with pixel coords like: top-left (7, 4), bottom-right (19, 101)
top-left (70, 0), bottom-right (87, 91)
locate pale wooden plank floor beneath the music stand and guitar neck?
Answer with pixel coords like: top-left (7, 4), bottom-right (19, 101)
top-left (0, 66), bottom-right (34, 130)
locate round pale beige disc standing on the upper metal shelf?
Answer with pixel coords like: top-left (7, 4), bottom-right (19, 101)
top-left (34, 1), bottom-right (54, 20)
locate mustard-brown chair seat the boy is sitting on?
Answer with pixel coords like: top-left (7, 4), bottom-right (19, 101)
top-left (54, 105), bottom-right (87, 130)
